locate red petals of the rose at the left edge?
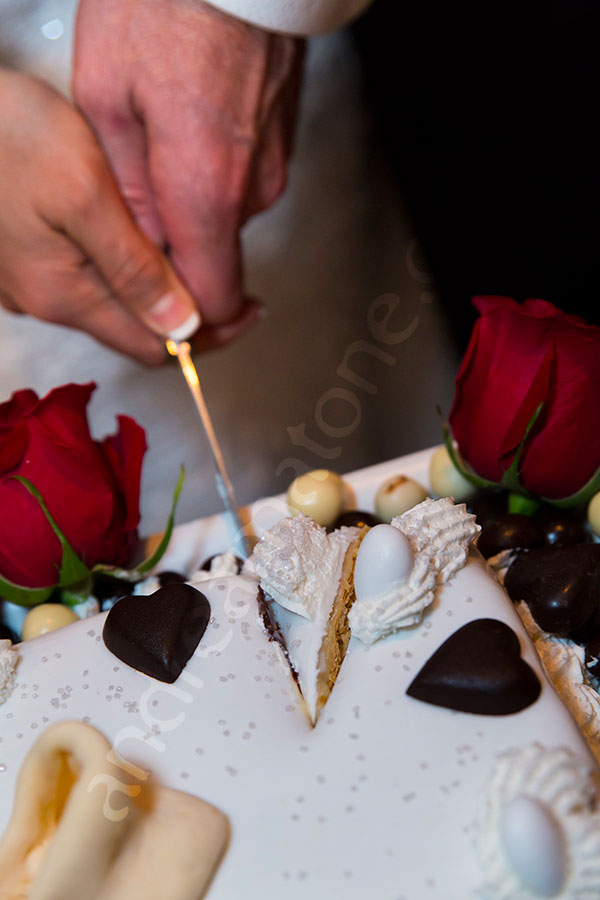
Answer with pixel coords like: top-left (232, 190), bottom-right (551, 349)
top-left (0, 384), bottom-right (146, 587)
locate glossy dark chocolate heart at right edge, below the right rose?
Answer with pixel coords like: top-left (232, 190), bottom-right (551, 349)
top-left (504, 544), bottom-right (600, 634)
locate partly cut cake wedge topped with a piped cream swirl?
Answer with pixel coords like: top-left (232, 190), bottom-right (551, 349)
top-left (246, 515), bottom-right (364, 725)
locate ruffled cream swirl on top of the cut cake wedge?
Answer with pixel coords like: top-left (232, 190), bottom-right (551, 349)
top-left (249, 515), bottom-right (358, 621)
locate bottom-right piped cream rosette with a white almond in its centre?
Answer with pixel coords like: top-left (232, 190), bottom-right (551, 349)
top-left (475, 743), bottom-right (600, 900)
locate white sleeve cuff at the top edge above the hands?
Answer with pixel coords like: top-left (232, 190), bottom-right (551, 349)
top-left (206, 0), bottom-right (371, 36)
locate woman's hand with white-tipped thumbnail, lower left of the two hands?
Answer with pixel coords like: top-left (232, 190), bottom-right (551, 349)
top-left (0, 70), bottom-right (209, 363)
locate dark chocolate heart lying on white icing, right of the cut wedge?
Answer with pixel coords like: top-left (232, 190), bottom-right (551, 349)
top-left (406, 619), bottom-right (541, 716)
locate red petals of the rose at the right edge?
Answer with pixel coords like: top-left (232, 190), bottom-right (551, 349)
top-left (450, 297), bottom-right (600, 499)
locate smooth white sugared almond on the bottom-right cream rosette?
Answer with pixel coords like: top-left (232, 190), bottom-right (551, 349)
top-left (500, 794), bottom-right (569, 897)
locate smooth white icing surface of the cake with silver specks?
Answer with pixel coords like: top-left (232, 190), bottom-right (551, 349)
top-left (0, 454), bottom-right (600, 900)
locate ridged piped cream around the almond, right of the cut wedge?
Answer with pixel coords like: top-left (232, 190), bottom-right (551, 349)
top-left (349, 497), bottom-right (481, 644)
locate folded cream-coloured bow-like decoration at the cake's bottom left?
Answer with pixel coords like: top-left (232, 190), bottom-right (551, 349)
top-left (0, 722), bottom-right (229, 900)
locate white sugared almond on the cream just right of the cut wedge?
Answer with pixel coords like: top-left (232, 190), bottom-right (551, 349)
top-left (354, 525), bottom-right (414, 603)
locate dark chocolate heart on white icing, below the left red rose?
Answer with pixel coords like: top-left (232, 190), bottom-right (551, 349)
top-left (102, 583), bottom-right (210, 684)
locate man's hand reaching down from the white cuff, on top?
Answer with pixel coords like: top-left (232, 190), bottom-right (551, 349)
top-left (73, 0), bottom-right (303, 335)
